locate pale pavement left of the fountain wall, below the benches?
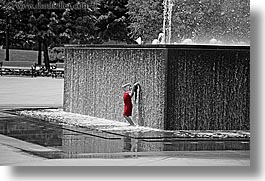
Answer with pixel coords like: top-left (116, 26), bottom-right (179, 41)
top-left (0, 76), bottom-right (63, 108)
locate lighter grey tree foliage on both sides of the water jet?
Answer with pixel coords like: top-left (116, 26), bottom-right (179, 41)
top-left (128, 0), bottom-right (250, 43)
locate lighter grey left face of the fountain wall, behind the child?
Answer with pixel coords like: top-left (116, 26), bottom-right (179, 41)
top-left (64, 47), bottom-right (166, 129)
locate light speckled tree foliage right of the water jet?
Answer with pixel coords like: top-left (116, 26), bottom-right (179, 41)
top-left (172, 0), bottom-right (250, 43)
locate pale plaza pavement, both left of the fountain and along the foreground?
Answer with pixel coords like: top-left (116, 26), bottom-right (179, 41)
top-left (0, 76), bottom-right (250, 166)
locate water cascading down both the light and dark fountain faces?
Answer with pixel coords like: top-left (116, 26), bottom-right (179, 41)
top-left (63, 45), bottom-right (250, 130)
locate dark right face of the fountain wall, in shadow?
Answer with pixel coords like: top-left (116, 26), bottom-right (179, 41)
top-left (165, 46), bottom-right (250, 130)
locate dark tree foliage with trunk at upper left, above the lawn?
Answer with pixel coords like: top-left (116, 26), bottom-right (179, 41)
top-left (0, 0), bottom-right (97, 69)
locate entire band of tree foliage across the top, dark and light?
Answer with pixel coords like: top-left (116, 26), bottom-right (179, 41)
top-left (0, 0), bottom-right (250, 51)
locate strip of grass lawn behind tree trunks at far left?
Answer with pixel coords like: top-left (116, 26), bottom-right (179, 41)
top-left (0, 49), bottom-right (42, 63)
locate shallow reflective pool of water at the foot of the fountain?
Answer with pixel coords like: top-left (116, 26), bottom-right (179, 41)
top-left (0, 111), bottom-right (250, 158)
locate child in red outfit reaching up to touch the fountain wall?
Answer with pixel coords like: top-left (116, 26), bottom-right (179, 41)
top-left (122, 82), bottom-right (140, 126)
